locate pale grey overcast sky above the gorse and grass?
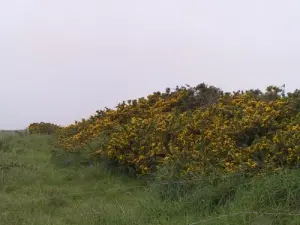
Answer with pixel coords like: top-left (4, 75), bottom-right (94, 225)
top-left (0, 0), bottom-right (300, 129)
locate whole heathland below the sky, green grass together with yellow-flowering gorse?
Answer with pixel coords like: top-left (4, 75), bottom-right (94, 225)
top-left (0, 84), bottom-right (300, 225)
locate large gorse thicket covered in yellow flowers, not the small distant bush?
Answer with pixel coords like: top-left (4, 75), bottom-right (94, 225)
top-left (33, 84), bottom-right (300, 176)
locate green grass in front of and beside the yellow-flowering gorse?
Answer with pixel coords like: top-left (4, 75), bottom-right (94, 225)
top-left (0, 134), bottom-right (300, 225)
